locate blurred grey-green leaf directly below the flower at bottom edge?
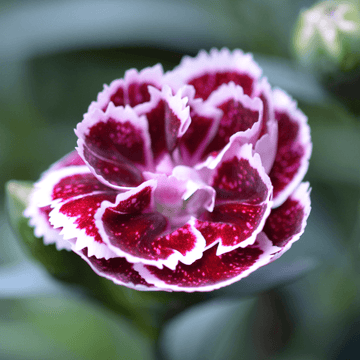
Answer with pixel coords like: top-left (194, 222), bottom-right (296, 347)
top-left (161, 299), bottom-right (255, 360)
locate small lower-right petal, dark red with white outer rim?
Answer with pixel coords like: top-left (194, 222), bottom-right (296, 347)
top-left (264, 183), bottom-right (311, 257)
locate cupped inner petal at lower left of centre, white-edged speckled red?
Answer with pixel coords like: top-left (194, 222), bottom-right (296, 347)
top-left (95, 180), bottom-right (205, 269)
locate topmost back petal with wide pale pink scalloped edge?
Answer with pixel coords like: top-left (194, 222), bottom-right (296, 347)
top-left (165, 48), bottom-right (261, 100)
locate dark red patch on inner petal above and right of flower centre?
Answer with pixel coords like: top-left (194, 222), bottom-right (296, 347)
top-left (205, 100), bottom-right (259, 154)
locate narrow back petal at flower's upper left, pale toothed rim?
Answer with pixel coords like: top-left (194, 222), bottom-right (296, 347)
top-left (88, 64), bottom-right (163, 112)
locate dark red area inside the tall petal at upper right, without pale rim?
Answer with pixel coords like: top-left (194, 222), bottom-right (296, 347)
top-left (269, 113), bottom-right (305, 197)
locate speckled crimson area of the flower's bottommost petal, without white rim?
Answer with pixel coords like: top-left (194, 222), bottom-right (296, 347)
top-left (146, 244), bottom-right (263, 288)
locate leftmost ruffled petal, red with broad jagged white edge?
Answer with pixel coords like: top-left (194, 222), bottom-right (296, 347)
top-left (29, 166), bottom-right (117, 258)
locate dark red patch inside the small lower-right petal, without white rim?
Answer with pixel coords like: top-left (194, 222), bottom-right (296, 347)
top-left (264, 198), bottom-right (304, 247)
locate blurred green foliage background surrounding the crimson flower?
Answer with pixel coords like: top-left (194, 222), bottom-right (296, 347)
top-left (0, 0), bottom-right (360, 360)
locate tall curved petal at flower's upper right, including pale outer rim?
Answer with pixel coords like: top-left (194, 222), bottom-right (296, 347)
top-left (269, 89), bottom-right (312, 207)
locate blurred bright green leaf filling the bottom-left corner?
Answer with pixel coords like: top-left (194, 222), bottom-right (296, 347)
top-left (0, 298), bottom-right (154, 360)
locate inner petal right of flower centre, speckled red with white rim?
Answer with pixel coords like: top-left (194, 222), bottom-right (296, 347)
top-left (196, 141), bottom-right (272, 255)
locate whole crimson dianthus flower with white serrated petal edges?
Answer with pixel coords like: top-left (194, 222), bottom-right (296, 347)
top-left (25, 49), bottom-right (312, 292)
